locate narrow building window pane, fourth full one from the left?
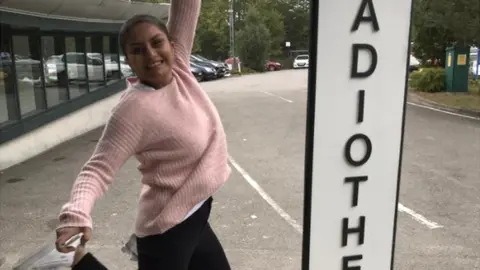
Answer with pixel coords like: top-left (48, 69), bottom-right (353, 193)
top-left (85, 36), bottom-right (105, 91)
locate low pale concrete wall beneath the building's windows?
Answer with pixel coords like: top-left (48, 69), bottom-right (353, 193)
top-left (0, 92), bottom-right (123, 170)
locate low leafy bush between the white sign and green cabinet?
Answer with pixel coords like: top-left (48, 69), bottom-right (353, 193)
top-left (410, 68), bottom-right (445, 93)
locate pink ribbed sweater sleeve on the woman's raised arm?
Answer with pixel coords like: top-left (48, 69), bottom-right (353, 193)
top-left (168, 0), bottom-right (201, 63)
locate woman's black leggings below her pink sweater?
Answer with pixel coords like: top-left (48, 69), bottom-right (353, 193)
top-left (73, 198), bottom-right (231, 270)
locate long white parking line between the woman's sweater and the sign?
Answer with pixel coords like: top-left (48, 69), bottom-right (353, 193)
top-left (228, 157), bottom-right (303, 234)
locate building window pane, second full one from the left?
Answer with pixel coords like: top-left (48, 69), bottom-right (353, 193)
top-left (41, 36), bottom-right (69, 108)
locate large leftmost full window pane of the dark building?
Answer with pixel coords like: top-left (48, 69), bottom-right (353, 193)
top-left (12, 35), bottom-right (46, 117)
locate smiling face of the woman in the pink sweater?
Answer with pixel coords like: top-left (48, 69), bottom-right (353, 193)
top-left (125, 22), bottom-right (174, 89)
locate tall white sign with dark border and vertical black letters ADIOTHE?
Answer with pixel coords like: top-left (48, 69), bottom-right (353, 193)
top-left (302, 0), bottom-right (412, 270)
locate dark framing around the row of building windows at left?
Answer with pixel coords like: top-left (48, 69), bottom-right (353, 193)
top-left (0, 11), bottom-right (126, 145)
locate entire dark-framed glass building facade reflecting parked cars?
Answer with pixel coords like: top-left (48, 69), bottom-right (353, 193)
top-left (0, 11), bottom-right (132, 144)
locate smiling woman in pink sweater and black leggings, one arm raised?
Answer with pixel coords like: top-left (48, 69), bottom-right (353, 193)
top-left (56, 0), bottom-right (231, 270)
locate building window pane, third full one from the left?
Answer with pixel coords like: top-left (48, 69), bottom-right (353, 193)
top-left (65, 37), bottom-right (88, 99)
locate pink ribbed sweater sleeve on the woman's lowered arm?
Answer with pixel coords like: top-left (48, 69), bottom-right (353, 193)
top-left (59, 97), bottom-right (142, 228)
